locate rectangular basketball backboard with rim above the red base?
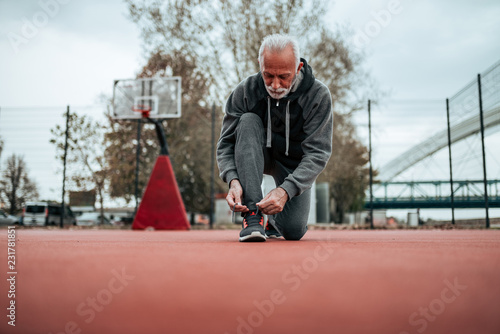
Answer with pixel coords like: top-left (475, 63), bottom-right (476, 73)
top-left (113, 77), bottom-right (181, 119)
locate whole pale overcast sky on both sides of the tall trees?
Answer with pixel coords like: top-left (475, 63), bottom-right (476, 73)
top-left (0, 0), bottom-right (500, 218)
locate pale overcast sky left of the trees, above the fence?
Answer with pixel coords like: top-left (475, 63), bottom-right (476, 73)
top-left (0, 0), bottom-right (142, 106)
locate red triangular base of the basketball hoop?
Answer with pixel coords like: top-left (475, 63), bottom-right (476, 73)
top-left (132, 155), bottom-right (191, 230)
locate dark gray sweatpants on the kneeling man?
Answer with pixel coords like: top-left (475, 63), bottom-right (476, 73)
top-left (234, 113), bottom-right (311, 240)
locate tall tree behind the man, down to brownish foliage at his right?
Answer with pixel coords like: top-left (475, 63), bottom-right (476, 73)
top-left (126, 0), bottom-right (372, 219)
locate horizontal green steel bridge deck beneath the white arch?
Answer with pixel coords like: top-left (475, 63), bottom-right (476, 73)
top-left (365, 180), bottom-right (500, 209)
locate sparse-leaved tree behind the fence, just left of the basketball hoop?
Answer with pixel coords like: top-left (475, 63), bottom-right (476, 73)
top-left (50, 112), bottom-right (109, 223)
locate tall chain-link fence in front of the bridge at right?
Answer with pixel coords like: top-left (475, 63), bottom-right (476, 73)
top-left (353, 62), bottom-right (500, 219)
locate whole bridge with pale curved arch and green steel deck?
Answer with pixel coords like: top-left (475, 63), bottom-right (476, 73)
top-left (365, 61), bottom-right (500, 209)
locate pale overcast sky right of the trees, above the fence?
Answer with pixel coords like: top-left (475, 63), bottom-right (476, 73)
top-left (332, 0), bottom-right (500, 99)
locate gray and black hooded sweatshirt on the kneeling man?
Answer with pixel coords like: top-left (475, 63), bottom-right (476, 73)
top-left (217, 59), bottom-right (333, 199)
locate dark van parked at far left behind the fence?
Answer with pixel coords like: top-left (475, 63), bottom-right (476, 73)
top-left (21, 202), bottom-right (76, 226)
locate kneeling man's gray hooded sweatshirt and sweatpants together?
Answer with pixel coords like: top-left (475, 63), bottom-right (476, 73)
top-left (217, 59), bottom-right (333, 240)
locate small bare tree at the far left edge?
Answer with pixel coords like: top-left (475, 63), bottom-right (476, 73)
top-left (0, 154), bottom-right (38, 214)
